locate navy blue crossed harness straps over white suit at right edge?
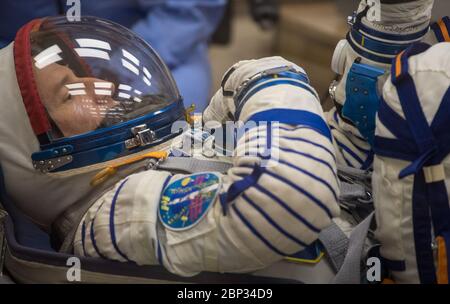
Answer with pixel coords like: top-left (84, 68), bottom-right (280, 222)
top-left (374, 43), bottom-right (450, 283)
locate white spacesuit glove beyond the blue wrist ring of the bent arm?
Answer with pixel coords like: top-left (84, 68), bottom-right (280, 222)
top-left (203, 56), bottom-right (305, 123)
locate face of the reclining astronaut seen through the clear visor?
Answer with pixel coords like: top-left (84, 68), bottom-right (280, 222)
top-left (34, 63), bottom-right (118, 137)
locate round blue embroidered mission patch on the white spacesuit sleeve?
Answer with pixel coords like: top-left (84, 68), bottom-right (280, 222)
top-left (159, 173), bottom-right (221, 231)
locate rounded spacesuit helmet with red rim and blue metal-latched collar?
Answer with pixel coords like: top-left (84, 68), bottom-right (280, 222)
top-left (14, 17), bottom-right (184, 172)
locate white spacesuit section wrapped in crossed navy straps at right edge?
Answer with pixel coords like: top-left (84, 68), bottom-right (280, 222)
top-left (373, 43), bottom-right (450, 284)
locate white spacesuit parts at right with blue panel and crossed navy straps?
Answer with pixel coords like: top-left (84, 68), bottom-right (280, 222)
top-left (328, 0), bottom-right (450, 283)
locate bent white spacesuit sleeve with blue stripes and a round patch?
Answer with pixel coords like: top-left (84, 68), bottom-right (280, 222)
top-left (74, 73), bottom-right (339, 276)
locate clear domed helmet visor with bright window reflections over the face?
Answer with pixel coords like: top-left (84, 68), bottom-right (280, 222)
top-left (30, 17), bottom-right (181, 139)
